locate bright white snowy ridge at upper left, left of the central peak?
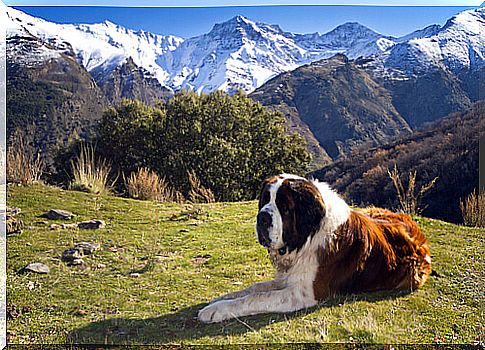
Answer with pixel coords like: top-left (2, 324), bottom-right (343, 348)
top-left (7, 8), bottom-right (183, 86)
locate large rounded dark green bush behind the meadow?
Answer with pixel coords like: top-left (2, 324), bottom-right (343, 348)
top-left (98, 91), bottom-right (310, 201)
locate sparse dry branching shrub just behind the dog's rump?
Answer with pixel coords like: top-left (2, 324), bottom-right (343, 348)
top-left (387, 164), bottom-right (438, 215)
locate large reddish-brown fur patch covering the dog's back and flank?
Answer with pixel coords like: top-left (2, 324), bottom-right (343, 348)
top-left (313, 208), bottom-right (431, 300)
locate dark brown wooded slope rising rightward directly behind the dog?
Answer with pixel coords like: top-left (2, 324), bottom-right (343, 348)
top-left (311, 101), bottom-right (485, 222)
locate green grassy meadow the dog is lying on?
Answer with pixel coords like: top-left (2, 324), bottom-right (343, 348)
top-left (7, 185), bottom-right (485, 344)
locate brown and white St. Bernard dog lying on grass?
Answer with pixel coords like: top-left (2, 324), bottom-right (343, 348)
top-left (199, 174), bottom-right (431, 322)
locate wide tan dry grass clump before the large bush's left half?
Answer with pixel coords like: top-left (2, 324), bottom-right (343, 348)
top-left (125, 168), bottom-right (181, 202)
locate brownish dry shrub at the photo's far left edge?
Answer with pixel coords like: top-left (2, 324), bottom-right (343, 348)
top-left (6, 132), bottom-right (45, 185)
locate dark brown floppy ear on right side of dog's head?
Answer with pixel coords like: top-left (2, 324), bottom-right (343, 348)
top-left (289, 179), bottom-right (326, 244)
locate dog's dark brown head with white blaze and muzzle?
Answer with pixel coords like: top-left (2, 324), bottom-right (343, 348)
top-left (256, 174), bottom-right (325, 255)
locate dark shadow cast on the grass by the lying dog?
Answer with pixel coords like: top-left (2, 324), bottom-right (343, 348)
top-left (67, 291), bottom-right (408, 344)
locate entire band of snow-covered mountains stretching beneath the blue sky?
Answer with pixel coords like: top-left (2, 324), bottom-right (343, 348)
top-left (7, 8), bottom-right (485, 92)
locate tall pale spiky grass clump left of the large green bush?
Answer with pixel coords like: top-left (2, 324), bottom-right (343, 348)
top-left (70, 144), bottom-right (111, 194)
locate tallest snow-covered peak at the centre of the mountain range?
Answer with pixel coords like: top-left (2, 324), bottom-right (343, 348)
top-left (160, 16), bottom-right (306, 92)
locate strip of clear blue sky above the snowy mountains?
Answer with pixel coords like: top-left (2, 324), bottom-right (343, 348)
top-left (6, 0), bottom-right (480, 37)
